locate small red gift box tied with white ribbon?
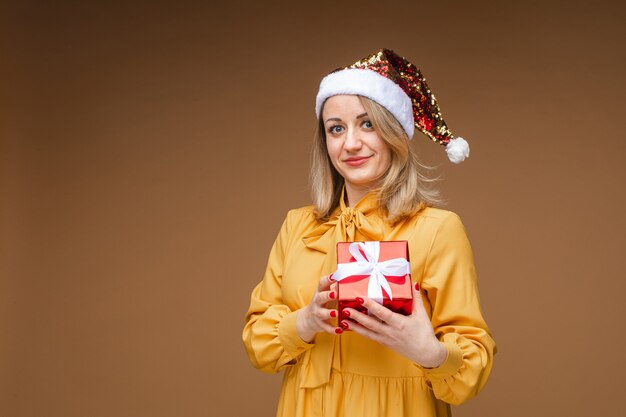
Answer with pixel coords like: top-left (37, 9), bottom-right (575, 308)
top-left (332, 241), bottom-right (413, 318)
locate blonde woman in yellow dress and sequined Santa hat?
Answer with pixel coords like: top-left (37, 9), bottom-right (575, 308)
top-left (243, 50), bottom-right (495, 417)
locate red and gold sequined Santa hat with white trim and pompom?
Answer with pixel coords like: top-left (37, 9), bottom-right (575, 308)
top-left (315, 49), bottom-right (469, 164)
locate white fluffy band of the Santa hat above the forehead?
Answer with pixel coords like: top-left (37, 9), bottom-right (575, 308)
top-left (315, 68), bottom-right (415, 139)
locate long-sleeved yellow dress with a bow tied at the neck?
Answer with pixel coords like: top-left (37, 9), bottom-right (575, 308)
top-left (243, 193), bottom-right (496, 417)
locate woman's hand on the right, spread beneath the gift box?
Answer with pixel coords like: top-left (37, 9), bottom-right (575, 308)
top-left (341, 284), bottom-right (448, 368)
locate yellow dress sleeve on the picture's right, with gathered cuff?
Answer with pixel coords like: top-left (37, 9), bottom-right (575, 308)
top-left (422, 213), bottom-right (496, 404)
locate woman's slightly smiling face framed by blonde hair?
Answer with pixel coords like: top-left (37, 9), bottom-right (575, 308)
top-left (322, 95), bottom-right (391, 199)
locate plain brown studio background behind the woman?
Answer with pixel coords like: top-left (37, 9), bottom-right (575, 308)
top-left (0, 1), bottom-right (626, 417)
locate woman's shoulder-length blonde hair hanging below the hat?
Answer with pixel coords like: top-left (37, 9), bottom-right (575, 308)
top-left (310, 96), bottom-right (442, 224)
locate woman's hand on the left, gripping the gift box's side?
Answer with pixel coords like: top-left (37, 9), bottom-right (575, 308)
top-left (296, 275), bottom-right (342, 343)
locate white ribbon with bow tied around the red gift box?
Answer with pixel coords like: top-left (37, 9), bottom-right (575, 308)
top-left (333, 242), bottom-right (411, 304)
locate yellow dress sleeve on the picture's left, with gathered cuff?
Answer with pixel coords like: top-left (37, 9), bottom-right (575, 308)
top-left (243, 213), bottom-right (314, 373)
